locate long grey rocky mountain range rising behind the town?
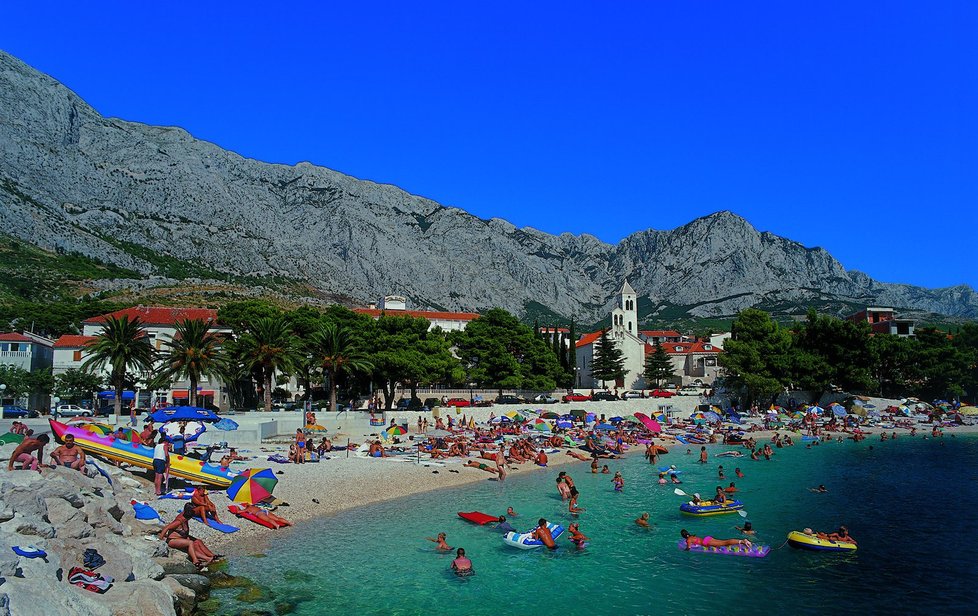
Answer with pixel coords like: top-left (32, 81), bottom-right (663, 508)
top-left (0, 52), bottom-right (978, 321)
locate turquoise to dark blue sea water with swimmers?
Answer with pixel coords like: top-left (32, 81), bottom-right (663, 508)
top-left (214, 437), bottom-right (978, 616)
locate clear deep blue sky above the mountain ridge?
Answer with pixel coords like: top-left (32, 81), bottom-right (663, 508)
top-left (0, 1), bottom-right (978, 287)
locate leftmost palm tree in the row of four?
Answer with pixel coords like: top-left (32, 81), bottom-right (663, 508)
top-left (82, 316), bottom-right (156, 418)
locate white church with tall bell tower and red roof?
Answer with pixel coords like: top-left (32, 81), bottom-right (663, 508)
top-left (574, 280), bottom-right (647, 390)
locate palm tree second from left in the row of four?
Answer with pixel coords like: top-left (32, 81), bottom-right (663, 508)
top-left (162, 319), bottom-right (223, 406)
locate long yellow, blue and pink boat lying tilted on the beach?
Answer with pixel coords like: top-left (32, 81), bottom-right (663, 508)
top-left (48, 419), bottom-right (238, 488)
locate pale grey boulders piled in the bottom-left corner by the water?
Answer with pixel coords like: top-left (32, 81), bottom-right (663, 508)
top-left (0, 460), bottom-right (203, 616)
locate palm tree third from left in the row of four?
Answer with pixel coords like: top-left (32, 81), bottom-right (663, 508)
top-left (236, 317), bottom-right (298, 412)
